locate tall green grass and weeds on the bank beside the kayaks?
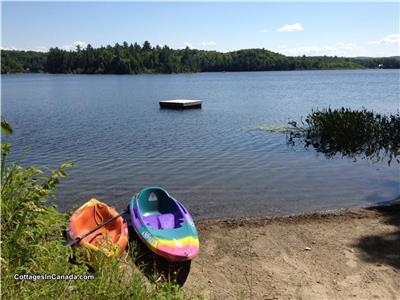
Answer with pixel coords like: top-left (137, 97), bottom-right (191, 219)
top-left (1, 121), bottom-right (198, 299)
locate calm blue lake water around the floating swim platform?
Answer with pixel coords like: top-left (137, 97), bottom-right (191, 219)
top-left (1, 70), bottom-right (400, 219)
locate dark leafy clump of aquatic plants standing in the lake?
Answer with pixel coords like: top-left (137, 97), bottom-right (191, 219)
top-left (287, 107), bottom-right (400, 165)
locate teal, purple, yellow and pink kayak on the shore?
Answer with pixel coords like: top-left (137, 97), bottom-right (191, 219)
top-left (130, 187), bottom-right (199, 261)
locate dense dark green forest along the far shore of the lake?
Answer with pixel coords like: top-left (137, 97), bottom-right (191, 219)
top-left (1, 41), bottom-right (400, 74)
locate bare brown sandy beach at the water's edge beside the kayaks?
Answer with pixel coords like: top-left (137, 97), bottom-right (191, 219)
top-left (184, 202), bottom-right (400, 299)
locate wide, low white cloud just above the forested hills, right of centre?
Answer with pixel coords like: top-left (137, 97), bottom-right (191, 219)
top-left (278, 42), bottom-right (361, 56)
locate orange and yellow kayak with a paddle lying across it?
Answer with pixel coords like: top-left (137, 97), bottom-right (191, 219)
top-left (68, 199), bottom-right (129, 256)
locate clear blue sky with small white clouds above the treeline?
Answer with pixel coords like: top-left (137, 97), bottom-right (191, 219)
top-left (2, 1), bottom-right (400, 56)
